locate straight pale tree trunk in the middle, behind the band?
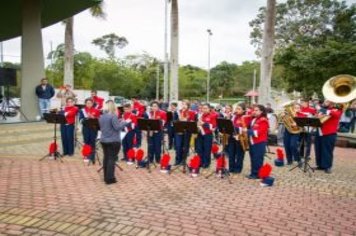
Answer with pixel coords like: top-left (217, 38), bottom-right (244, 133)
top-left (169, 0), bottom-right (179, 101)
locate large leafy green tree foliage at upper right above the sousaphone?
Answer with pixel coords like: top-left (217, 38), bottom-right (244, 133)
top-left (250, 0), bottom-right (356, 96)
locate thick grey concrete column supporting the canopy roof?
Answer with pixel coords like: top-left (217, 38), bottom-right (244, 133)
top-left (21, 0), bottom-right (45, 121)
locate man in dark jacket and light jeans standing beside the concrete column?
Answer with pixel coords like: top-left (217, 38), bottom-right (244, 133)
top-left (36, 78), bottom-right (54, 118)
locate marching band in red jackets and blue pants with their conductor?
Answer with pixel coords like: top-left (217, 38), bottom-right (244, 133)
top-left (46, 73), bottom-right (354, 184)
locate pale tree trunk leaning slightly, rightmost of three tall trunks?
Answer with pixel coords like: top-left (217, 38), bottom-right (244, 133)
top-left (258, 0), bottom-right (276, 104)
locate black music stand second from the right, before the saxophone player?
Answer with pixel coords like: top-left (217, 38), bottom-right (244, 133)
top-left (205, 118), bottom-right (235, 184)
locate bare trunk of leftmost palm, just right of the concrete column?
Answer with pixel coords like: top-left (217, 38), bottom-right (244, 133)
top-left (64, 17), bottom-right (74, 88)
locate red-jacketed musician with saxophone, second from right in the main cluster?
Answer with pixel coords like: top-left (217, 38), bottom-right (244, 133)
top-left (227, 103), bottom-right (251, 174)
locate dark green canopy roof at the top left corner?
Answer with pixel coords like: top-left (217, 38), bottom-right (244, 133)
top-left (0, 0), bottom-right (101, 41)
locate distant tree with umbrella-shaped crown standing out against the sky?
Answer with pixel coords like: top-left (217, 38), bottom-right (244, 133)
top-left (92, 33), bottom-right (129, 60)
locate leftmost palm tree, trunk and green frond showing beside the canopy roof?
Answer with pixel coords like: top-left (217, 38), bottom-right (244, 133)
top-left (63, 1), bottom-right (106, 88)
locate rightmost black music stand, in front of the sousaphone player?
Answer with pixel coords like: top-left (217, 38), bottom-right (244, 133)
top-left (289, 117), bottom-right (321, 177)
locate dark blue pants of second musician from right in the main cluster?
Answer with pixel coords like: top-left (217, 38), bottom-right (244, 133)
top-left (227, 138), bottom-right (245, 173)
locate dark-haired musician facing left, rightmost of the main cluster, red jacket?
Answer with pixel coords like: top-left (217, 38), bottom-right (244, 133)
top-left (243, 105), bottom-right (268, 179)
